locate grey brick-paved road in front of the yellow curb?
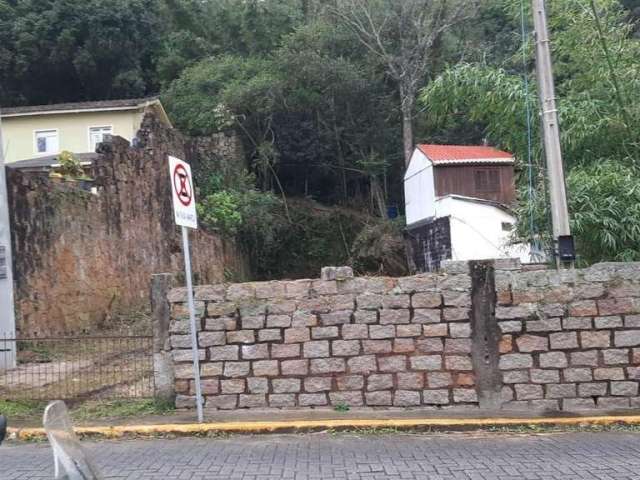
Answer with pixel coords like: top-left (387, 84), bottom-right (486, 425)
top-left (0, 433), bottom-right (640, 480)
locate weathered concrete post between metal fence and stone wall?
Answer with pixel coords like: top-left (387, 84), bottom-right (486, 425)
top-left (151, 273), bottom-right (176, 403)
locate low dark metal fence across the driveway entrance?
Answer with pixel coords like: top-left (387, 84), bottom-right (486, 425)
top-left (0, 334), bottom-right (154, 400)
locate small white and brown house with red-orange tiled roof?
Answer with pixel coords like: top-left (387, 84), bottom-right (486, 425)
top-left (404, 145), bottom-right (530, 271)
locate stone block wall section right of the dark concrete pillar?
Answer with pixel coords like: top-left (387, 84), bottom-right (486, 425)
top-left (496, 263), bottom-right (640, 410)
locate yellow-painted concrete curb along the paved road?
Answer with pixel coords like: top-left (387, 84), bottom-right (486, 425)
top-left (7, 415), bottom-right (640, 440)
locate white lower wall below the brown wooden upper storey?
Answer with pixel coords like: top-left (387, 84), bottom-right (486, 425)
top-left (435, 195), bottom-right (531, 263)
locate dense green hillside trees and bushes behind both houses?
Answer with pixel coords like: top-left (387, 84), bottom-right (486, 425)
top-left (0, 0), bottom-right (640, 270)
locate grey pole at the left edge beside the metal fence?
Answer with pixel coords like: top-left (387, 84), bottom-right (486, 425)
top-left (0, 112), bottom-right (16, 370)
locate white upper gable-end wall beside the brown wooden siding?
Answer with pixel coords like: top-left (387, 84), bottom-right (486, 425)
top-left (404, 148), bottom-right (436, 225)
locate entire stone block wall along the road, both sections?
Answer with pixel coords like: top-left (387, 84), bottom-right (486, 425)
top-left (169, 260), bottom-right (640, 410)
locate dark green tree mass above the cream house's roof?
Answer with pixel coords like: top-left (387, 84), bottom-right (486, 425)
top-left (0, 0), bottom-right (161, 105)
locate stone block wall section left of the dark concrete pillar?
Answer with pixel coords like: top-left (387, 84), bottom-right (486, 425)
top-left (169, 270), bottom-right (477, 409)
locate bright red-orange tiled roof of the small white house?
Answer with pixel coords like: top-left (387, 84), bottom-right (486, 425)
top-left (416, 144), bottom-right (515, 166)
